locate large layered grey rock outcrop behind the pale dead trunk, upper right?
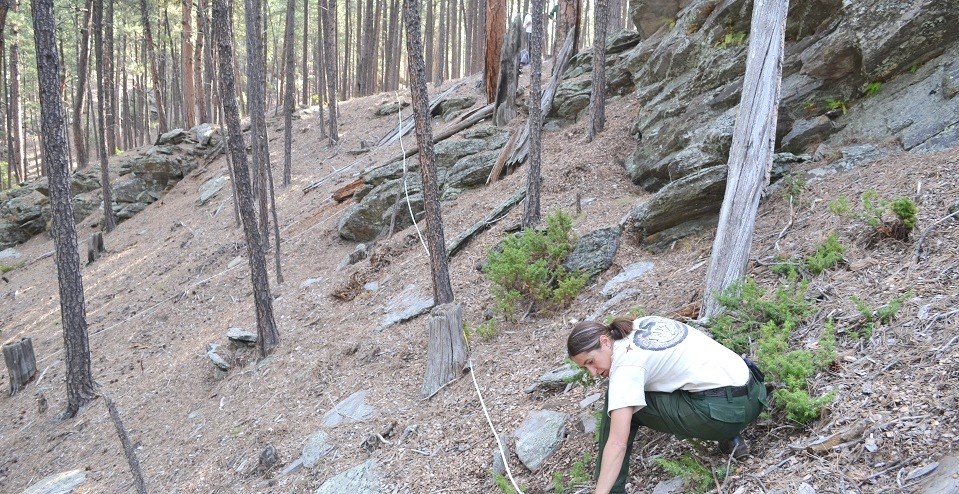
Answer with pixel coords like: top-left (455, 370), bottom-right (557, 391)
top-left (616, 0), bottom-right (959, 245)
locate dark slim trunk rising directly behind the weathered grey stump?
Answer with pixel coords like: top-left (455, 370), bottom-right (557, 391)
top-left (403, 0), bottom-right (453, 305)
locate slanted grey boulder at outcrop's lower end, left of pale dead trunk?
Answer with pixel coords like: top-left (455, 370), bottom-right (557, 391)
top-left (630, 166), bottom-right (726, 241)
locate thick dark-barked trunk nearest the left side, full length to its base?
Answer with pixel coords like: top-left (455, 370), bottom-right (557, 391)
top-left (31, 0), bottom-right (96, 418)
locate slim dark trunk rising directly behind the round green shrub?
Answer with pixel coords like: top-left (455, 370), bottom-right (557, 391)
top-left (523, 0), bottom-right (548, 228)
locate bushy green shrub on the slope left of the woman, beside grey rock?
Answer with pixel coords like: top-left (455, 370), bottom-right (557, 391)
top-left (486, 211), bottom-right (588, 319)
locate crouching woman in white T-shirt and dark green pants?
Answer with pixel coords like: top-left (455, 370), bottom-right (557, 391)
top-left (566, 316), bottom-right (767, 494)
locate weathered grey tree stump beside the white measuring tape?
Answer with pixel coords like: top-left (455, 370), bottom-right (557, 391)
top-left (420, 302), bottom-right (466, 398)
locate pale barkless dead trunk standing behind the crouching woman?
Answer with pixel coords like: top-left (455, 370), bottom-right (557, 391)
top-left (700, 0), bottom-right (789, 320)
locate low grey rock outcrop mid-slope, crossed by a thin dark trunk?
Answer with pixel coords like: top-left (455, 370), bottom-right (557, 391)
top-left (338, 129), bottom-right (508, 242)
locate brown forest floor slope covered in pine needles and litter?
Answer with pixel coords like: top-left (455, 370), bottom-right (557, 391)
top-left (0, 66), bottom-right (959, 493)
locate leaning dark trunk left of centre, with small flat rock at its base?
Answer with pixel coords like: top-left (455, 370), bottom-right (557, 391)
top-left (213, 0), bottom-right (280, 357)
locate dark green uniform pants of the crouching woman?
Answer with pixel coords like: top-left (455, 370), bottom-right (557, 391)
top-left (594, 379), bottom-right (767, 494)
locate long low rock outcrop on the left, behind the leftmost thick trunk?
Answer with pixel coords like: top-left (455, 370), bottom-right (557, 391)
top-left (0, 124), bottom-right (223, 249)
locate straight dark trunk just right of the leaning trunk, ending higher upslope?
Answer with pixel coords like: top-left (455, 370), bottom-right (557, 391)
top-left (244, 0), bottom-right (270, 246)
